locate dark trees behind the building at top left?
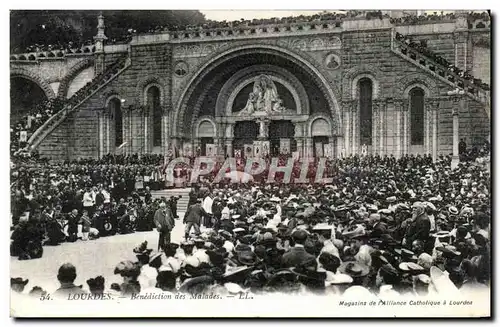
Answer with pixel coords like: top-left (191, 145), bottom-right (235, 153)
top-left (10, 10), bottom-right (205, 52)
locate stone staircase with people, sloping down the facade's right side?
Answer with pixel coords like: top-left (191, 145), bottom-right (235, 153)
top-left (391, 33), bottom-right (491, 118)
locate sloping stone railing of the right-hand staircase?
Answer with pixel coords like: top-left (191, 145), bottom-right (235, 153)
top-left (392, 38), bottom-right (489, 103)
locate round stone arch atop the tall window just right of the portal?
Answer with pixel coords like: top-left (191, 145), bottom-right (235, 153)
top-left (343, 65), bottom-right (382, 100)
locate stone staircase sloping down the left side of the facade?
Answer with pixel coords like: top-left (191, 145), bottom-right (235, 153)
top-left (27, 54), bottom-right (131, 151)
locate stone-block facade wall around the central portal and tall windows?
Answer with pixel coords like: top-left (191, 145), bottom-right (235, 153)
top-left (34, 29), bottom-right (489, 159)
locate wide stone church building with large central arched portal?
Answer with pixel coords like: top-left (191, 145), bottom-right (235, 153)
top-left (10, 12), bottom-right (490, 160)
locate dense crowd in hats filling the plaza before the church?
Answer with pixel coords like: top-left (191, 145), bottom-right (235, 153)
top-left (11, 142), bottom-right (491, 297)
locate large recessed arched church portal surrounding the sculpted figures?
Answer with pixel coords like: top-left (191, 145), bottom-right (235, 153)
top-left (171, 45), bottom-right (342, 159)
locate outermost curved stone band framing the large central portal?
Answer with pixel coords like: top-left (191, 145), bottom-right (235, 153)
top-left (173, 44), bottom-right (341, 136)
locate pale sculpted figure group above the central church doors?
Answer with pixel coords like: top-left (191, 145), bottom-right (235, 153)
top-left (240, 75), bottom-right (285, 115)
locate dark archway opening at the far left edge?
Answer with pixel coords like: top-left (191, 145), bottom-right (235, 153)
top-left (10, 76), bottom-right (48, 124)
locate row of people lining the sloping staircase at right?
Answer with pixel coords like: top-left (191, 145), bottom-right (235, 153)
top-left (396, 33), bottom-right (490, 90)
